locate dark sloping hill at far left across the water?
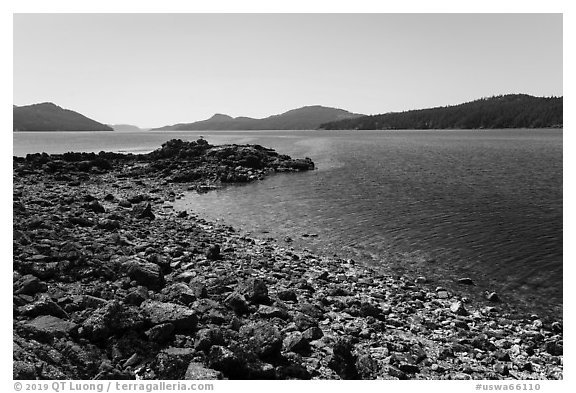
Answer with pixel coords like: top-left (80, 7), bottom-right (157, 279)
top-left (13, 102), bottom-right (113, 131)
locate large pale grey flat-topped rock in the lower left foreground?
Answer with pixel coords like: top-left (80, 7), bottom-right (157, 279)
top-left (140, 300), bottom-right (198, 332)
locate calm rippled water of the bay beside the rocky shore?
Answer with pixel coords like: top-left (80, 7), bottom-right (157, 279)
top-left (14, 130), bottom-right (562, 315)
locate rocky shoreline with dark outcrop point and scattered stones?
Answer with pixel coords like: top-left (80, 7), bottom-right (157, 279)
top-left (13, 140), bottom-right (563, 380)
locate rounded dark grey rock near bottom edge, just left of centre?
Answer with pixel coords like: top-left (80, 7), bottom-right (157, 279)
top-left (239, 322), bottom-right (282, 359)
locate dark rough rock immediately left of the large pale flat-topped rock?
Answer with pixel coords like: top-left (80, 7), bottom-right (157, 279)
top-left (80, 300), bottom-right (144, 342)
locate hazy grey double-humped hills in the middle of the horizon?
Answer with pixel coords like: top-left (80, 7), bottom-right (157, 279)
top-left (155, 105), bottom-right (363, 131)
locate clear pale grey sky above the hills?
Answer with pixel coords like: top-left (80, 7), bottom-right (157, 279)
top-left (14, 14), bottom-right (563, 127)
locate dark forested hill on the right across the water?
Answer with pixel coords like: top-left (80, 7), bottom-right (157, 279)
top-left (319, 94), bottom-right (563, 130)
